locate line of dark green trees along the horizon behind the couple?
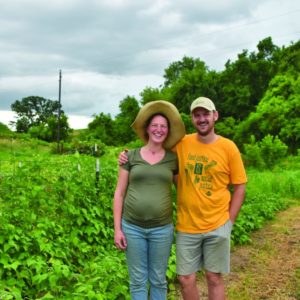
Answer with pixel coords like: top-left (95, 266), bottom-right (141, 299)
top-left (4, 37), bottom-right (300, 164)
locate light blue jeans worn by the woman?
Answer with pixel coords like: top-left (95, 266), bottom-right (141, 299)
top-left (122, 220), bottom-right (173, 300)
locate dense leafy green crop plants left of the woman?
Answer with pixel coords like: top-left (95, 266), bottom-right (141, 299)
top-left (0, 155), bottom-right (129, 299)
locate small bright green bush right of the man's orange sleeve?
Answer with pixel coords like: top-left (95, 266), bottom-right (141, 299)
top-left (244, 134), bottom-right (288, 170)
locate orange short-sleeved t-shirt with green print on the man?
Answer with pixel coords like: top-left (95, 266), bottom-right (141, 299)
top-left (174, 133), bottom-right (247, 233)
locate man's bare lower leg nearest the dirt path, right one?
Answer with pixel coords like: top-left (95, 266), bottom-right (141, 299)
top-left (205, 271), bottom-right (225, 300)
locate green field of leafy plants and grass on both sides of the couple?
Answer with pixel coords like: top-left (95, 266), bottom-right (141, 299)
top-left (0, 139), bottom-right (300, 300)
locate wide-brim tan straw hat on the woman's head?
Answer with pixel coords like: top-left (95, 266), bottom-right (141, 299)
top-left (131, 100), bottom-right (185, 149)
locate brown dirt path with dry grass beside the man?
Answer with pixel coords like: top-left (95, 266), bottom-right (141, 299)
top-left (175, 202), bottom-right (300, 300)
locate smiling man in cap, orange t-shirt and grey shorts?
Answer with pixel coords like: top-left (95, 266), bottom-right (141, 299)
top-left (119, 97), bottom-right (247, 300)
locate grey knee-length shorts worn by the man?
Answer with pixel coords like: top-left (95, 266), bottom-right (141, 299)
top-left (176, 220), bottom-right (232, 275)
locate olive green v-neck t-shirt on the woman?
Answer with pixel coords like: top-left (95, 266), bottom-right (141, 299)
top-left (122, 148), bottom-right (178, 228)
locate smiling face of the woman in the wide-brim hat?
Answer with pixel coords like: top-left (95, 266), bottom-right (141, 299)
top-left (147, 115), bottom-right (169, 143)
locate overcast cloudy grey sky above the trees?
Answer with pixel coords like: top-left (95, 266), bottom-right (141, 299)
top-left (0, 0), bottom-right (300, 129)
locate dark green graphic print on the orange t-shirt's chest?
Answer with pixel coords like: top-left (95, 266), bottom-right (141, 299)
top-left (185, 153), bottom-right (217, 196)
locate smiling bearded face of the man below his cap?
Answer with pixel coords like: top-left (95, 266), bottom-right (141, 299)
top-left (192, 107), bottom-right (218, 136)
